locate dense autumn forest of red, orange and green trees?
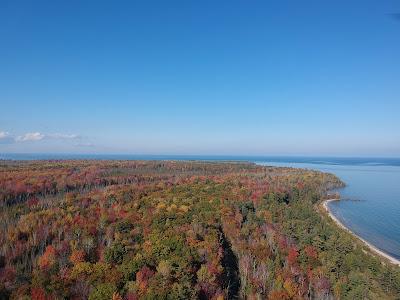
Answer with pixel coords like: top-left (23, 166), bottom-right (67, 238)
top-left (0, 161), bottom-right (400, 300)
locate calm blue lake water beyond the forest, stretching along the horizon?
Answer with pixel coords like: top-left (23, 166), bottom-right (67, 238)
top-left (0, 154), bottom-right (400, 259)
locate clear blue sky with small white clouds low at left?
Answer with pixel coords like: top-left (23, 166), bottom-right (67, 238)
top-left (0, 0), bottom-right (400, 156)
